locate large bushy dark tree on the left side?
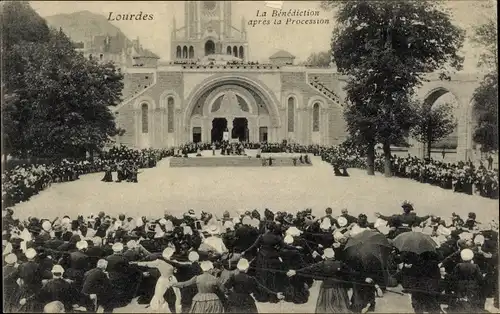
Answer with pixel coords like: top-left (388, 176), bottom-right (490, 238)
top-left (2, 2), bottom-right (123, 157)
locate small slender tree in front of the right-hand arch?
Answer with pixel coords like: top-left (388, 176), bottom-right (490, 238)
top-left (412, 104), bottom-right (457, 158)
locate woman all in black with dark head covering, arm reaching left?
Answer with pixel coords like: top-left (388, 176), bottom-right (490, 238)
top-left (242, 222), bottom-right (288, 302)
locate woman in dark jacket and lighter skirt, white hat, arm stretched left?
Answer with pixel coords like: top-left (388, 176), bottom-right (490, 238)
top-left (287, 248), bottom-right (350, 313)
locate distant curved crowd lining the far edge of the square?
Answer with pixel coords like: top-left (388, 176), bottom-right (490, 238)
top-left (2, 141), bottom-right (499, 210)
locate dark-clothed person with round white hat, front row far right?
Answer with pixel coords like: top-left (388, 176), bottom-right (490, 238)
top-left (450, 249), bottom-right (484, 313)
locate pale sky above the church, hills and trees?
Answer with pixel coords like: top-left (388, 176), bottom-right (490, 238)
top-left (30, 0), bottom-right (496, 72)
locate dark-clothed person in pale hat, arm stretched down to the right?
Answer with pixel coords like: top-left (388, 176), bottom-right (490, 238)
top-left (224, 258), bottom-right (284, 313)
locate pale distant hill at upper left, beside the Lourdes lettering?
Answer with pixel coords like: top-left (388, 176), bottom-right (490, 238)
top-left (45, 11), bottom-right (126, 42)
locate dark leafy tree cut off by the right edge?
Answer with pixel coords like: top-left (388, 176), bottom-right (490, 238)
top-left (472, 72), bottom-right (498, 152)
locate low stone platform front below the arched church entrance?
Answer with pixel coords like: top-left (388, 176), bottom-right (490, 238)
top-left (170, 156), bottom-right (312, 168)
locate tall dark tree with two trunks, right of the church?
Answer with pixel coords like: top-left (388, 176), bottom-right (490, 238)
top-left (323, 0), bottom-right (464, 176)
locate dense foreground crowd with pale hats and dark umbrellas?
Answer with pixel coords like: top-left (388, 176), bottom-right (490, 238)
top-left (2, 201), bottom-right (498, 313)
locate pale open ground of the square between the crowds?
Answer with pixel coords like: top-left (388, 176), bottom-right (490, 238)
top-left (14, 157), bottom-right (498, 313)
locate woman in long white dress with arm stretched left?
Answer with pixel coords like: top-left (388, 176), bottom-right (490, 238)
top-left (133, 247), bottom-right (182, 313)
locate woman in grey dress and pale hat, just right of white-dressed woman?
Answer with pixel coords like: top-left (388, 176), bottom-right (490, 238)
top-left (172, 261), bottom-right (224, 313)
